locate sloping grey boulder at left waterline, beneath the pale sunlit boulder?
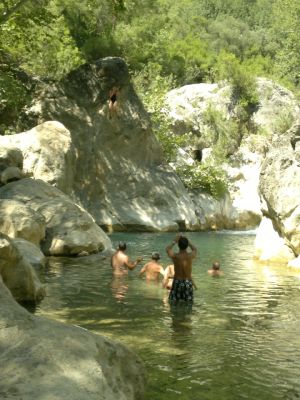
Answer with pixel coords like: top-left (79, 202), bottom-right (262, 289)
top-left (0, 178), bottom-right (111, 256)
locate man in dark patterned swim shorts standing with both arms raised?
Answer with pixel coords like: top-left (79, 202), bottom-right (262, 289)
top-left (166, 235), bottom-right (197, 304)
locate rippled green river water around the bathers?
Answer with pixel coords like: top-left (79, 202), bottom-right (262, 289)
top-left (36, 232), bottom-right (300, 400)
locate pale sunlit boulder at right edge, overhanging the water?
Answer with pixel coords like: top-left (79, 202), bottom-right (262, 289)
top-left (259, 121), bottom-right (300, 261)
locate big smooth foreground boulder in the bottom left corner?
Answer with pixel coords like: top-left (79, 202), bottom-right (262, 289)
top-left (0, 276), bottom-right (145, 400)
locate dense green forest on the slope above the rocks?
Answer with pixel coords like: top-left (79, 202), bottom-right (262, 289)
top-left (0, 0), bottom-right (300, 142)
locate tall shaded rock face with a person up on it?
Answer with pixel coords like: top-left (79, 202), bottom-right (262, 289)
top-left (20, 57), bottom-right (197, 231)
